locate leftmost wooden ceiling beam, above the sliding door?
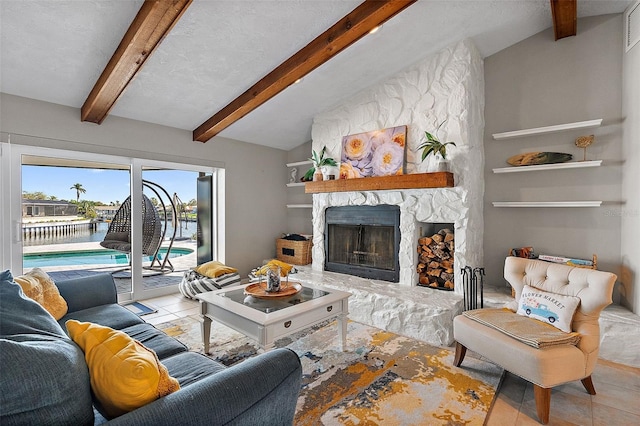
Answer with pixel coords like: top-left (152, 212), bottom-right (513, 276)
top-left (80, 0), bottom-right (192, 124)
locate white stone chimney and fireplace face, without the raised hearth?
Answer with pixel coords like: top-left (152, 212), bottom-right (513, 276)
top-left (311, 40), bottom-right (484, 294)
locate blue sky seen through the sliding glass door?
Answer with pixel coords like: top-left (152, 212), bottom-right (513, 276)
top-left (22, 166), bottom-right (198, 205)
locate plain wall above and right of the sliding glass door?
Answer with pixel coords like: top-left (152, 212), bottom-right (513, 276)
top-left (0, 94), bottom-right (287, 277)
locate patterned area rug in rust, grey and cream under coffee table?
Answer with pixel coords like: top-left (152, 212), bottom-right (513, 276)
top-left (157, 317), bottom-right (503, 425)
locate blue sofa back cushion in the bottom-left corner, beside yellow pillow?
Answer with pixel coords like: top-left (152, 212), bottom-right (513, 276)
top-left (0, 271), bottom-right (94, 426)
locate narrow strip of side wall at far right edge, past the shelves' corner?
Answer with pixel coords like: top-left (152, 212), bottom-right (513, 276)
top-left (620, 5), bottom-right (640, 314)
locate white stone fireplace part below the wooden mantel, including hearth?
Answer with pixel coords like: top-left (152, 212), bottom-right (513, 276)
top-left (296, 187), bottom-right (478, 346)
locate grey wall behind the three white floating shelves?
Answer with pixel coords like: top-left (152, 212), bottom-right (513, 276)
top-left (484, 15), bottom-right (624, 297)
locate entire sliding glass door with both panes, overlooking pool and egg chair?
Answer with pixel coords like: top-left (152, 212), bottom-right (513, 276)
top-left (0, 144), bottom-right (218, 300)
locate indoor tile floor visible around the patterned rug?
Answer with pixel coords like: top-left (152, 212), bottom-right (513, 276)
top-left (143, 294), bottom-right (640, 426)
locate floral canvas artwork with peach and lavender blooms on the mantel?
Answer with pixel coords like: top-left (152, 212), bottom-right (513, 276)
top-left (340, 126), bottom-right (407, 179)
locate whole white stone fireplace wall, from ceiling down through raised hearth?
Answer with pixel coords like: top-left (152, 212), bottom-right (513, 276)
top-left (296, 40), bottom-right (484, 346)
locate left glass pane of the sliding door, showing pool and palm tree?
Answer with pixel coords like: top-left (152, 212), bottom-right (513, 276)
top-left (20, 153), bottom-right (133, 294)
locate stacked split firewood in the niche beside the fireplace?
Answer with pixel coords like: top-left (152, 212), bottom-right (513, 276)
top-left (417, 229), bottom-right (454, 290)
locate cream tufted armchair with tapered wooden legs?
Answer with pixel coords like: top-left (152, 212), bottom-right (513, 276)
top-left (453, 257), bottom-right (617, 424)
